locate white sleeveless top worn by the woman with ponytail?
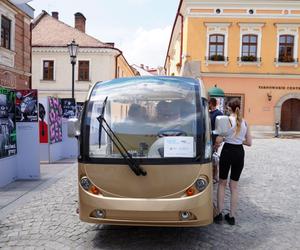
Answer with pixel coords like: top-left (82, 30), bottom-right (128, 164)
top-left (224, 115), bottom-right (247, 145)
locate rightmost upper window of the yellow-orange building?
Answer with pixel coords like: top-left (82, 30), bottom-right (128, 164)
top-left (278, 35), bottom-right (295, 62)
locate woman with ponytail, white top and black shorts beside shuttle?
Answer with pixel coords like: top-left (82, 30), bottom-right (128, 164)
top-left (214, 99), bottom-right (252, 225)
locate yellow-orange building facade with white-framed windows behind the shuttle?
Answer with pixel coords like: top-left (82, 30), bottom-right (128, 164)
top-left (165, 0), bottom-right (300, 131)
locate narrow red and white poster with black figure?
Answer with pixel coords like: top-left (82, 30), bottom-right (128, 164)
top-left (39, 98), bottom-right (49, 143)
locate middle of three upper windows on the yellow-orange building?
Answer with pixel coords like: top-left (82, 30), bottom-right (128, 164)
top-left (241, 35), bottom-right (258, 62)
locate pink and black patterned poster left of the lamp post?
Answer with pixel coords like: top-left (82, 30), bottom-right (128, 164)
top-left (48, 97), bottom-right (62, 144)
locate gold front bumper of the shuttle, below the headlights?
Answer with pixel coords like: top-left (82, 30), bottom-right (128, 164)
top-left (79, 185), bottom-right (213, 226)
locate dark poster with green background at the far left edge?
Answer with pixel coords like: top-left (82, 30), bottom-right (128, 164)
top-left (0, 87), bottom-right (17, 158)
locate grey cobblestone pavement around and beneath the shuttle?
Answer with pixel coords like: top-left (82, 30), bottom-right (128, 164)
top-left (0, 139), bottom-right (300, 250)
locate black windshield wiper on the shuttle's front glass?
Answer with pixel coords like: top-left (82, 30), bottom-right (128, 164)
top-left (97, 97), bottom-right (147, 176)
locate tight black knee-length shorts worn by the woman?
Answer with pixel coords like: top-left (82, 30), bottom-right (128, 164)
top-left (219, 143), bottom-right (245, 181)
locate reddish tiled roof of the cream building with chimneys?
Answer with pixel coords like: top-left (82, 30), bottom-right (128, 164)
top-left (32, 11), bottom-right (112, 48)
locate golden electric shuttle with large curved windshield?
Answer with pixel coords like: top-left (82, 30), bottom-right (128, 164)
top-left (69, 76), bottom-right (213, 226)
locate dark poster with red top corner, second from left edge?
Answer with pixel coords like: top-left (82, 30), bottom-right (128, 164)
top-left (16, 89), bottom-right (38, 122)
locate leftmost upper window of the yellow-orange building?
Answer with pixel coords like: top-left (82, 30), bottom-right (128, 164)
top-left (208, 34), bottom-right (225, 61)
